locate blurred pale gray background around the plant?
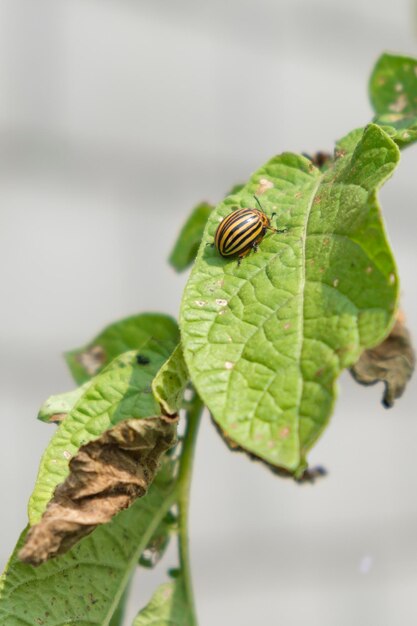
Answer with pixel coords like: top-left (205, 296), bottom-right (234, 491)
top-left (0, 0), bottom-right (417, 626)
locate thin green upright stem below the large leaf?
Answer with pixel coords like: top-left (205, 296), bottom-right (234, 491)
top-left (178, 394), bottom-right (204, 626)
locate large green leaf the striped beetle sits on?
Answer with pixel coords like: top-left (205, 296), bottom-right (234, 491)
top-left (181, 125), bottom-right (399, 475)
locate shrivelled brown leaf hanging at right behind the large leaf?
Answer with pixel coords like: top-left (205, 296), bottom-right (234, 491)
top-left (351, 312), bottom-right (415, 408)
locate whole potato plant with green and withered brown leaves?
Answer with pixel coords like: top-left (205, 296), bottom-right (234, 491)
top-left (0, 55), bottom-right (417, 626)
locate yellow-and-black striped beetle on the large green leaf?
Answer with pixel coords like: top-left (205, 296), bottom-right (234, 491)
top-left (214, 196), bottom-right (284, 263)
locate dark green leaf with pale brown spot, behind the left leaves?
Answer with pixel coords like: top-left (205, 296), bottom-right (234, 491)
top-left (65, 313), bottom-right (179, 385)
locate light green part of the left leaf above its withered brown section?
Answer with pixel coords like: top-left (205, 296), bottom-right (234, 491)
top-left (29, 338), bottom-right (170, 525)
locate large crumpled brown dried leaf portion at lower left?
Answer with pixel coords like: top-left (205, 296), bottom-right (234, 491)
top-left (19, 417), bottom-right (177, 565)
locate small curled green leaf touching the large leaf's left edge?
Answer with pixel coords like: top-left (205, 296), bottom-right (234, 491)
top-left (152, 345), bottom-right (190, 415)
